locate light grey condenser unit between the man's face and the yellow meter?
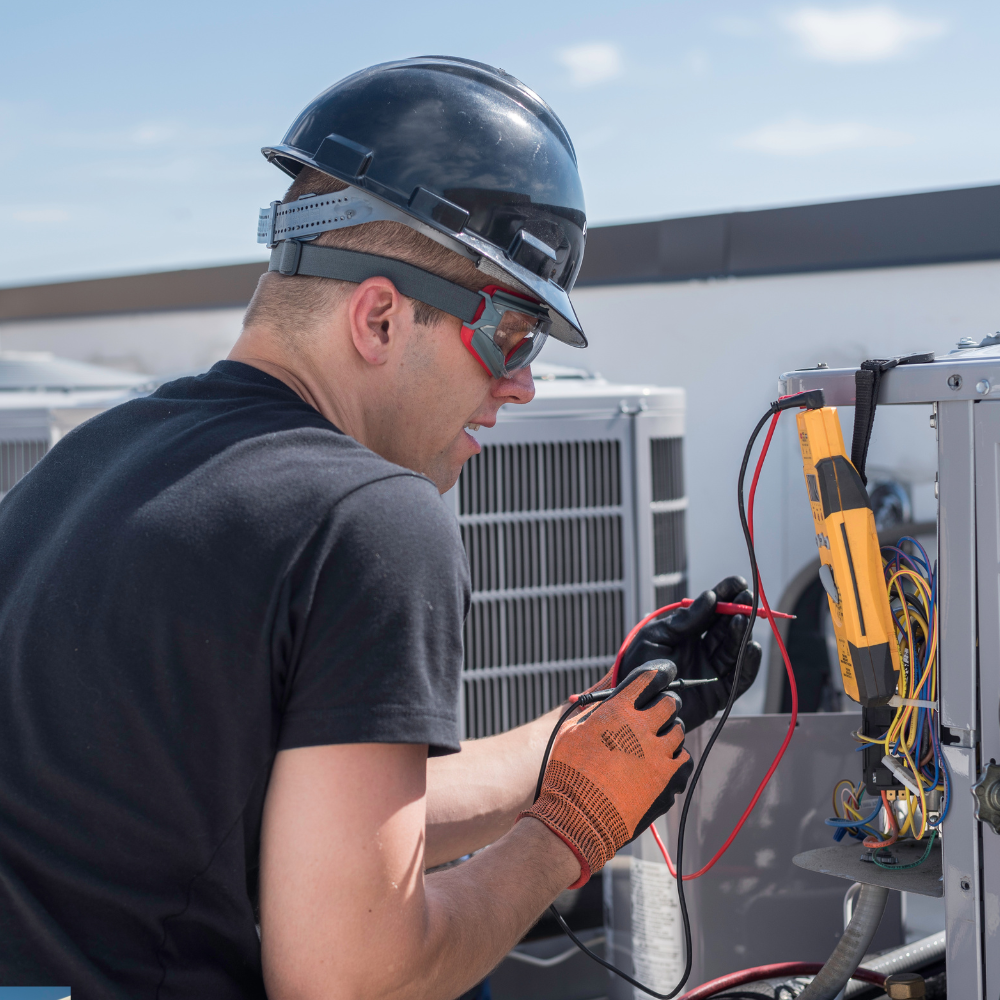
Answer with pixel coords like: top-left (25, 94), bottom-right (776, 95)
top-left (447, 364), bottom-right (687, 738)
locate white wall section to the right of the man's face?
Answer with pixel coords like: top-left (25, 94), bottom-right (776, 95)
top-left (543, 262), bottom-right (1000, 711)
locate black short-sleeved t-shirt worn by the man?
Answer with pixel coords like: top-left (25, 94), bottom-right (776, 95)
top-left (0, 361), bottom-right (469, 1000)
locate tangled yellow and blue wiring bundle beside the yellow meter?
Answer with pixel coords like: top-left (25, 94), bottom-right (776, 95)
top-left (826, 537), bottom-right (951, 871)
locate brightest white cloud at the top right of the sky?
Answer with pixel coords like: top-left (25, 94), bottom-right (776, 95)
top-left (783, 4), bottom-right (948, 63)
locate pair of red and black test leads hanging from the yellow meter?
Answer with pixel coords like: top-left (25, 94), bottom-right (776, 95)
top-left (536, 390), bottom-right (823, 1000)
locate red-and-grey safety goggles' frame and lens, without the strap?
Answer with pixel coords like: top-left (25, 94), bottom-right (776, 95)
top-left (462, 285), bottom-right (552, 378)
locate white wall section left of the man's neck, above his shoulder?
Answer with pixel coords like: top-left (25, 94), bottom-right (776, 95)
top-left (0, 308), bottom-right (245, 377)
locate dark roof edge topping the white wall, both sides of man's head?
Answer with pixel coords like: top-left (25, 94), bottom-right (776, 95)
top-left (0, 184), bottom-right (1000, 324)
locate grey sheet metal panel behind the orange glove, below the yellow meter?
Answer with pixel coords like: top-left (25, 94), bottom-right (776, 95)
top-left (605, 713), bottom-right (902, 1000)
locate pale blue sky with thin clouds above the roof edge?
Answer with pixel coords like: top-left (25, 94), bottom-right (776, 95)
top-left (0, 0), bottom-right (1000, 285)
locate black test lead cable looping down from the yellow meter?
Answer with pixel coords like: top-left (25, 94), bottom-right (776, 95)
top-left (535, 406), bottom-right (777, 1000)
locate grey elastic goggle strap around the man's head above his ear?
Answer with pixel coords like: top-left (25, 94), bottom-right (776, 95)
top-left (267, 240), bottom-right (483, 323)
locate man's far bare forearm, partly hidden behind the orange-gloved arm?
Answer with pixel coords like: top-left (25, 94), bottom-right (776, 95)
top-left (425, 706), bottom-right (565, 868)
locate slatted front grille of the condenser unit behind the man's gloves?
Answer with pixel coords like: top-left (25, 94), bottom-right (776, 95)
top-left (459, 440), bottom-right (626, 736)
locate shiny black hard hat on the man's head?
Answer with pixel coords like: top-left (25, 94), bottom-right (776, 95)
top-left (261, 56), bottom-right (587, 347)
